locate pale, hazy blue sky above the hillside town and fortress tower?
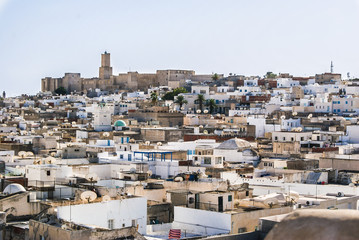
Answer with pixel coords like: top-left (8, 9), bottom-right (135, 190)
top-left (0, 0), bottom-right (359, 96)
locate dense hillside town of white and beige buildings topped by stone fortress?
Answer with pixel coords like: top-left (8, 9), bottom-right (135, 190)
top-left (0, 52), bottom-right (359, 240)
